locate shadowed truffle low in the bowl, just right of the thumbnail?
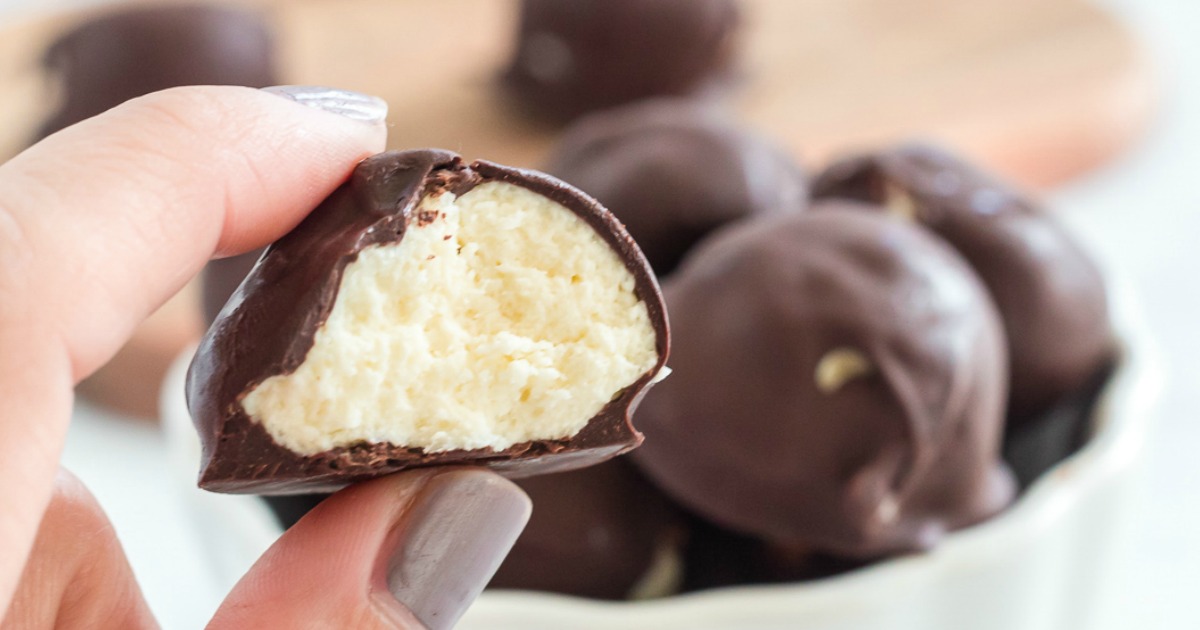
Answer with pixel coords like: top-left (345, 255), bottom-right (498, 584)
top-left (488, 458), bottom-right (683, 600)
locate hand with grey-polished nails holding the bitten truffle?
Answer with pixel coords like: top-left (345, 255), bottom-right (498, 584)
top-left (0, 88), bottom-right (529, 628)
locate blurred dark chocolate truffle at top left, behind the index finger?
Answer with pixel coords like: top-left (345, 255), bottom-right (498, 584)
top-left (38, 5), bottom-right (278, 138)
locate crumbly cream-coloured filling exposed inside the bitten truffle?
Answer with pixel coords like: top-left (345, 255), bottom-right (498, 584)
top-left (242, 182), bottom-right (658, 455)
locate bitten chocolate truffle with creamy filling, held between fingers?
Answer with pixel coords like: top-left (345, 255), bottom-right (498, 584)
top-left (187, 150), bottom-right (667, 493)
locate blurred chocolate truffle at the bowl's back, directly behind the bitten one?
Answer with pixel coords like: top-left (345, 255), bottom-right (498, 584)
top-left (546, 100), bottom-right (808, 276)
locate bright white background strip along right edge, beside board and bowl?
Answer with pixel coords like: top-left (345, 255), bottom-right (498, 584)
top-left (1052, 0), bottom-right (1200, 630)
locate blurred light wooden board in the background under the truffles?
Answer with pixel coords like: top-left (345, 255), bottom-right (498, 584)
top-left (0, 0), bottom-right (1156, 186)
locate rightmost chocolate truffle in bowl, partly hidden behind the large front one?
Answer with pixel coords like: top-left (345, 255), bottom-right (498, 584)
top-left (814, 144), bottom-right (1115, 426)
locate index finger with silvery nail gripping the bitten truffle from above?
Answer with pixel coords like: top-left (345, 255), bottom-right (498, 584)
top-left (0, 86), bottom-right (385, 610)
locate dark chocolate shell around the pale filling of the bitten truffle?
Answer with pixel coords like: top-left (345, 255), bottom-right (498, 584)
top-left (187, 149), bottom-right (668, 494)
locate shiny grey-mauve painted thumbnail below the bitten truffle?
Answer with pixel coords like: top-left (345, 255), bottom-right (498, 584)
top-left (388, 469), bottom-right (530, 630)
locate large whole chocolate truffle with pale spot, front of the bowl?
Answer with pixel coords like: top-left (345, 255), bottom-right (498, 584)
top-left (634, 204), bottom-right (1014, 558)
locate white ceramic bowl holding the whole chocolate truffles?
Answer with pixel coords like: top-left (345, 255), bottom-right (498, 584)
top-left (162, 292), bottom-right (1160, 630)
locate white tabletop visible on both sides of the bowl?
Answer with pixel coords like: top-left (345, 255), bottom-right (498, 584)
top-left (0, 0), bottom-right (1200, 630)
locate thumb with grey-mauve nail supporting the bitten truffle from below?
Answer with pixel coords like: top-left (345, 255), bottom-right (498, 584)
top-left (209, 468), bottom-right (530, 630)
